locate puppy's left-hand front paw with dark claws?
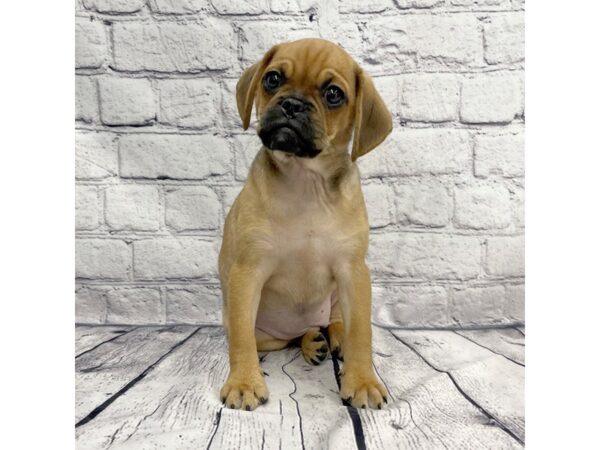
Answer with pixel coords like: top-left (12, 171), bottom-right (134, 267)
top-left (220, 369), bottom-right (269, 411)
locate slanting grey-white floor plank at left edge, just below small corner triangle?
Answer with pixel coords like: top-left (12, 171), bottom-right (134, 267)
top-left (75, 326), bottom-right (196, 422)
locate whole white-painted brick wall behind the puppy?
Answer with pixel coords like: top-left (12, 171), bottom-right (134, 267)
top-left (75, 0), bottom-right (525, 327)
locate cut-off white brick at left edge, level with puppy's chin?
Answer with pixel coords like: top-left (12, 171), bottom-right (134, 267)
top-left (75, 131), bottom-right (118, 180)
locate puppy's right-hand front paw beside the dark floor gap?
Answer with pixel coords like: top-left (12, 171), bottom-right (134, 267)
top-left (340, 370), bottom-right (388, 409)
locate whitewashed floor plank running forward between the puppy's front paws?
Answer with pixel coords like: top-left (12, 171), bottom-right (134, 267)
top-left (211, 348), bottom-right (356, 449)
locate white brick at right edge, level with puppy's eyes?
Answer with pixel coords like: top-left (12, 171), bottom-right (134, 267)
top-left (460, 73), bottom-right (521, 123)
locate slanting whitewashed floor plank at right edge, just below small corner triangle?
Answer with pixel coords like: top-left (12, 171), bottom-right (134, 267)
top-left (393, 331), bottom-right (525, 442)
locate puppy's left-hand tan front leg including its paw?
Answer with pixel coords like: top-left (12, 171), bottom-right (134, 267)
top-left (220, 264), bottom-right (269, 411)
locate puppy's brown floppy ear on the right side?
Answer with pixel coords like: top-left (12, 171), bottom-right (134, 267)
top-left (352, 67), bottom-right (392, 161)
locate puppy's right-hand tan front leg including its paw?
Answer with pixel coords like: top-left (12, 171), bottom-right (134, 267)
top-left (336, 258), bottom-right (387, 409)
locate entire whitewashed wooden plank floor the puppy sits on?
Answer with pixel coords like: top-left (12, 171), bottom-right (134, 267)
top-left (75, 326), bottom-right (525, 450)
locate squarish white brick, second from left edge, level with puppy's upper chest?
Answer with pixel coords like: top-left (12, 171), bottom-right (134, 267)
top-left (106, 185), bottom-right (160, 231)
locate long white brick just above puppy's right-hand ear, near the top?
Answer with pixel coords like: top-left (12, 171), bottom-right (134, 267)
top-left (356, 14), bottom-right (483, 72)
